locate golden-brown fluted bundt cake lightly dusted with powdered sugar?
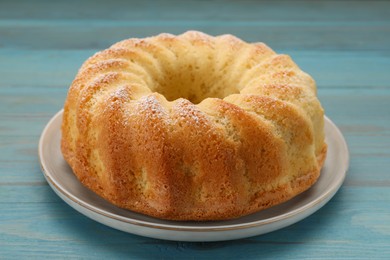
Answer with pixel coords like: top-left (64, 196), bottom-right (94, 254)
top-left (61, 31), bottom-right (327, 221)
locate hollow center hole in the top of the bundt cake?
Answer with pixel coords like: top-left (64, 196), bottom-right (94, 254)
top-left (153, 64), bottom-right (239, 104)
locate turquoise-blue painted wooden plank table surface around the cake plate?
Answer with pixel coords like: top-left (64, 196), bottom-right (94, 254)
top-left (0, 0), bottom-right (390, 259)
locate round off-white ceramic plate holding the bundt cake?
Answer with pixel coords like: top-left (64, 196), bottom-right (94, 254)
top-left (39, 111), bottom-right (349, 241)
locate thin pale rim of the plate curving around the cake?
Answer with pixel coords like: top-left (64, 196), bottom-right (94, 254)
top-left (38, 109), bottom-right (350, 234)
